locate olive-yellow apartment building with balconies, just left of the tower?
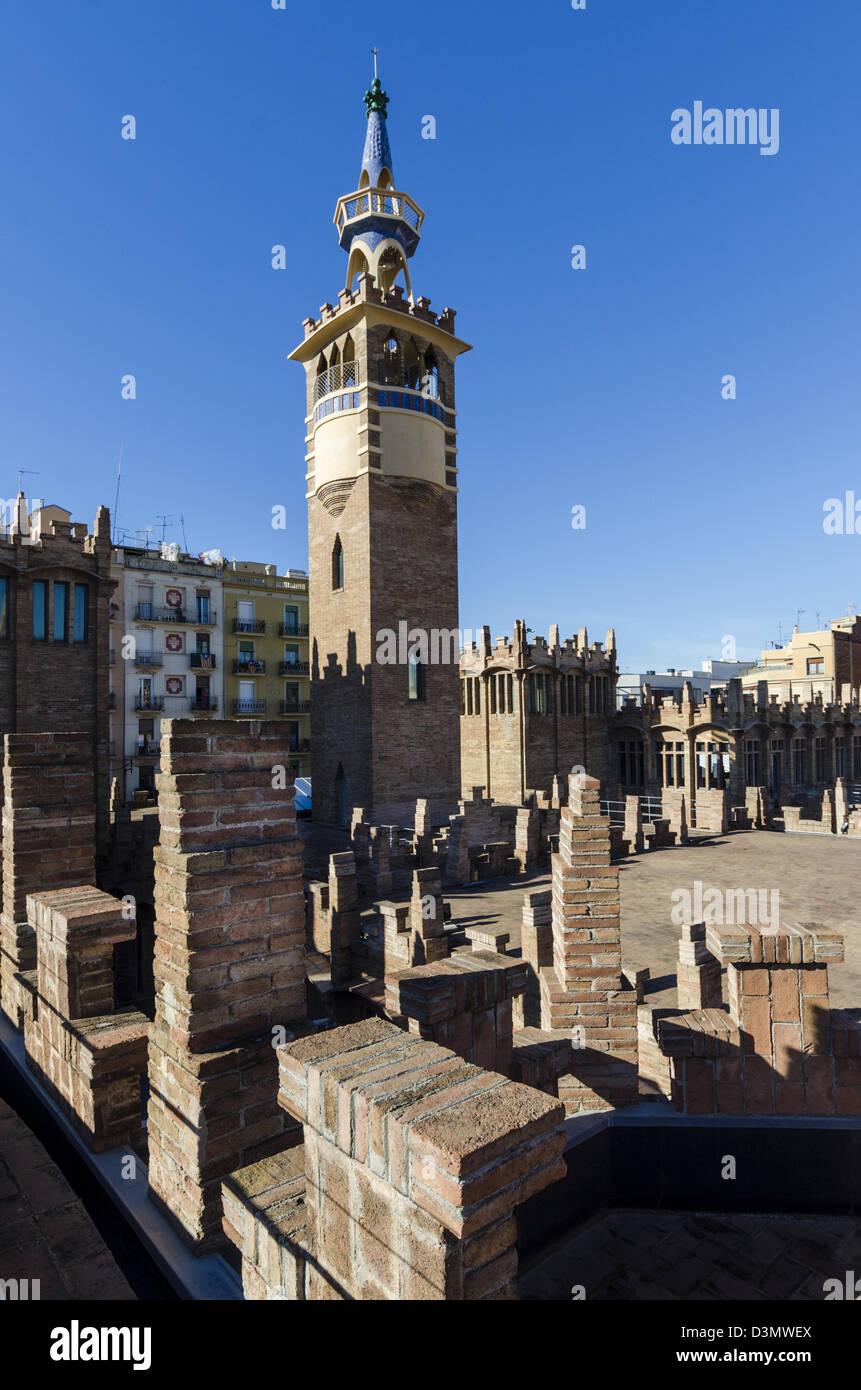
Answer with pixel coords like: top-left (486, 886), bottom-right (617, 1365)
top-left (224, 560), bottom-right (310, 777)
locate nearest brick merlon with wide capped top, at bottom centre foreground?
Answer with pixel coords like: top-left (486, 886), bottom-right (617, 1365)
top-left (278, 1020), bottom-right (565, 1301)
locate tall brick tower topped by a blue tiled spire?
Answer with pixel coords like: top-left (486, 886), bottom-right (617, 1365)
top-left (291, 78), bottom-right (469, 827)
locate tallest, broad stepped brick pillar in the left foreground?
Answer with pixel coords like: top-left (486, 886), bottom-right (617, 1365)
top-left (149, 720), bottom-right (305, 1251)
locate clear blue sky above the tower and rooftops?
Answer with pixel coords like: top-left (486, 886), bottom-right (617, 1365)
top-left (0, 0), bottom-right (861, 669)
